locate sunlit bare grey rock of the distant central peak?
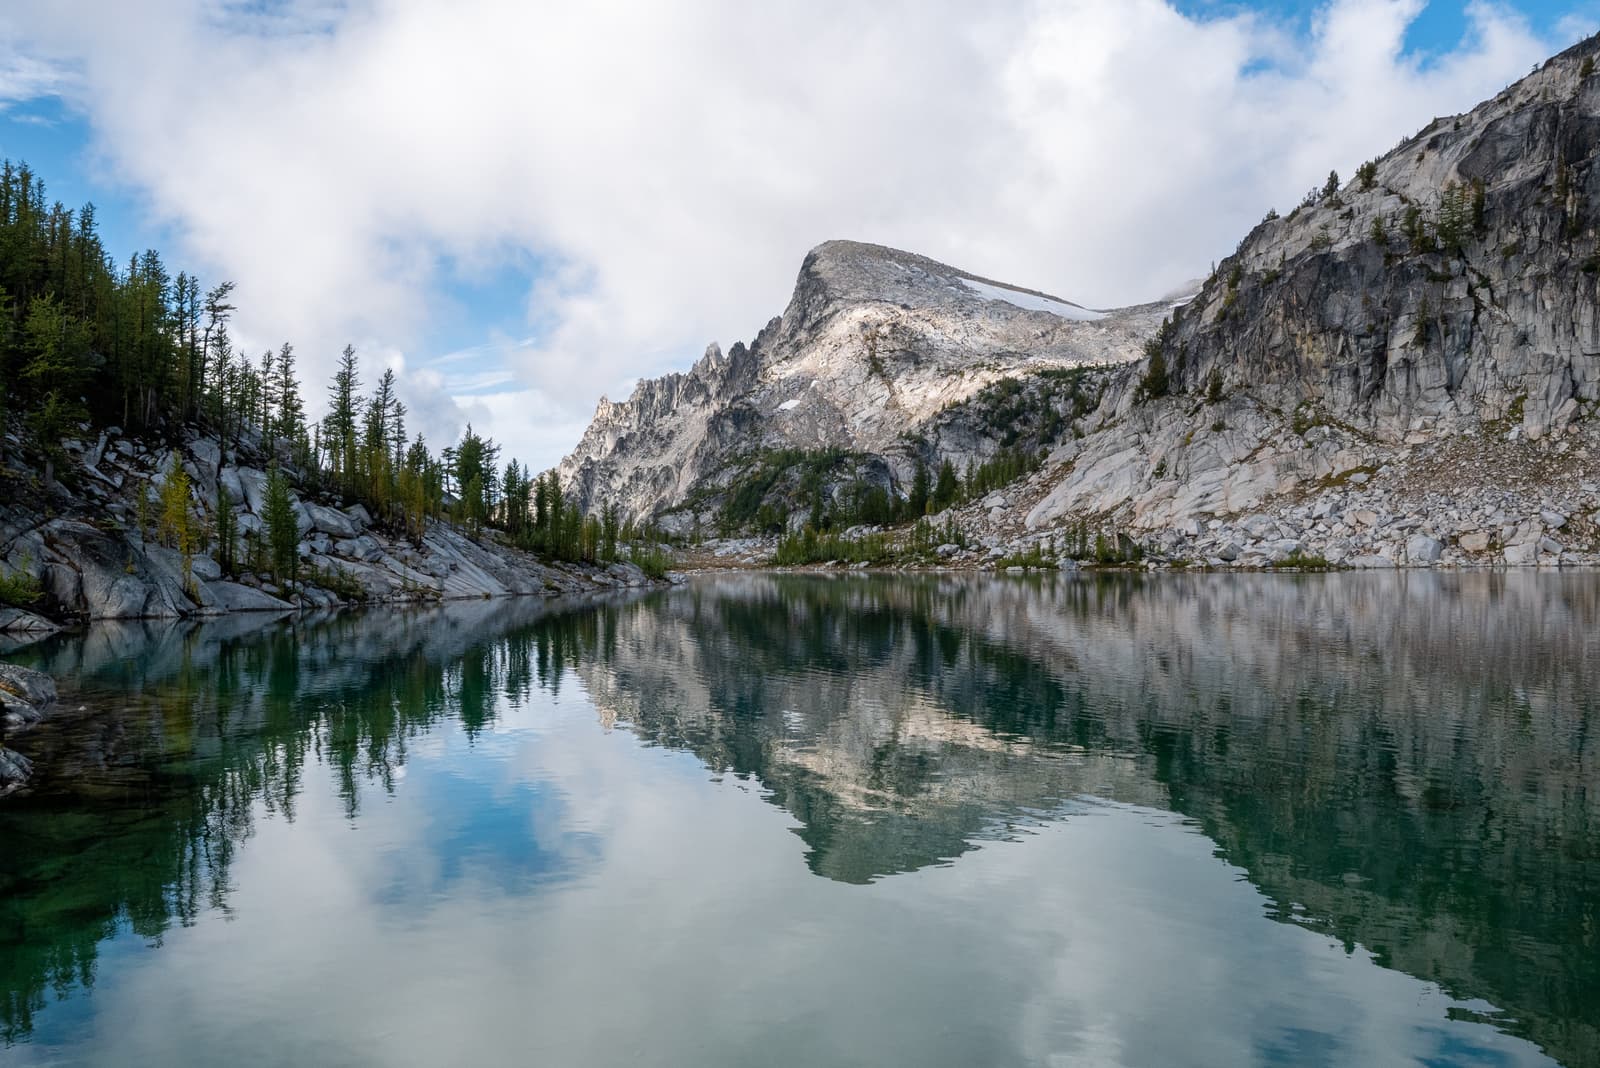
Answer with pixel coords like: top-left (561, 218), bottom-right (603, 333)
top-left (560, 241), bottom-right (1168, 518)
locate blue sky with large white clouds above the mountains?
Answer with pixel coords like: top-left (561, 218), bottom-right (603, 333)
top-left (0, 0), bottom-right (1600, 470)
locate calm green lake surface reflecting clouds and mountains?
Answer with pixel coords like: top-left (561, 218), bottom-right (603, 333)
top-left (0, 574), bottom-right (1600, 1068)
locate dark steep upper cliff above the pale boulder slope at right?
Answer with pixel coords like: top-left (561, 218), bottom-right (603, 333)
top-left (1168, 42), bottom-right (1600, 443)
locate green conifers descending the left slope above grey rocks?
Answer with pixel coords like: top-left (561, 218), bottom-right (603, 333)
top-left (0, 160), bottom-right (642, 571)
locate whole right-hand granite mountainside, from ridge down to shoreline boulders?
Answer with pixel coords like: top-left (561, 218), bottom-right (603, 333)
top-left (1018, 33), bottom-right (1600, 566)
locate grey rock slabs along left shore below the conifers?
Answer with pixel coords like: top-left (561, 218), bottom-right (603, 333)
top-left (0, 430), bottom-right (662, 617)
